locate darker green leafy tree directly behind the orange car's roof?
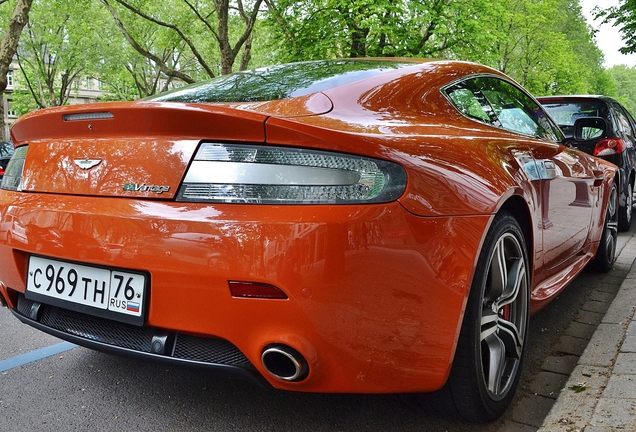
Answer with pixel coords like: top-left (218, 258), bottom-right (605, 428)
top-left (265, 0), bottom-right (491, 60)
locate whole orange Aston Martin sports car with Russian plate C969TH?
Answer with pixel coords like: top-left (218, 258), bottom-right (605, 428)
top-left (0, 59), bottom-right (620, 421)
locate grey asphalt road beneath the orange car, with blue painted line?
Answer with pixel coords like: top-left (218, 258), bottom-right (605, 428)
top-left (0, 224), bottom-right (636, 432)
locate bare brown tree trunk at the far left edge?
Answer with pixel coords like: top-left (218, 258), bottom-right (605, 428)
top-left (0, 0), bottom-right (33, 141)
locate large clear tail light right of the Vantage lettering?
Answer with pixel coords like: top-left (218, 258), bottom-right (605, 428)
top-left (177, 143), bottom-right (406, 204)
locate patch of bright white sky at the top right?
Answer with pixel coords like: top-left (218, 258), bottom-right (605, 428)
top-left (580, 0), bottom-right (636, 68)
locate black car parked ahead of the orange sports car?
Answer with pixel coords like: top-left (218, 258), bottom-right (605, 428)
top-left (537, 95), bottom-right (636, 231)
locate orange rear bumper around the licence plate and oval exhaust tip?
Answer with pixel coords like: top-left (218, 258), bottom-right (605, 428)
top-left (0, 191), bottom-right (490, 393)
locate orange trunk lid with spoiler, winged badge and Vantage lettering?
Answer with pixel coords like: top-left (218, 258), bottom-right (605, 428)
top-left (11, 102), bottom-right (267, 199)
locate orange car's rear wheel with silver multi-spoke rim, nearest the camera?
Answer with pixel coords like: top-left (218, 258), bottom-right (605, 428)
top-left (418, 213), bottom-right (530, 423)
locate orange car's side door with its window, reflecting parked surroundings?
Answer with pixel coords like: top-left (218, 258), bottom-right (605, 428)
top-left (475, 77), bottom-right (600, 278)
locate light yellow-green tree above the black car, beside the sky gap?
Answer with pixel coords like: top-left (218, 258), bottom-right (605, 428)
top-left (474, 0), bottom-right (604, 94)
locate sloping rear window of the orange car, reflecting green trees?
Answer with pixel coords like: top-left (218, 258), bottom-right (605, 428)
top-left (145, 60), bottom-right (413, 103)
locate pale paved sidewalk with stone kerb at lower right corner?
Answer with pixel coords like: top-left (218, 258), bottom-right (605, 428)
top-left (539, 235), bottom-right (636, 432)
